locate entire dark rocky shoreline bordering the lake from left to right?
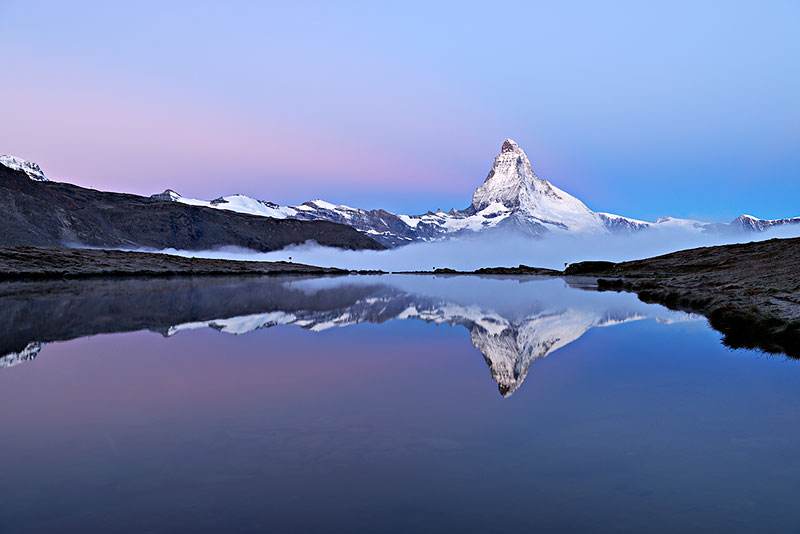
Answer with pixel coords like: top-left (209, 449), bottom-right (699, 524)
top-left (0, 238), bottom-right (800, 358)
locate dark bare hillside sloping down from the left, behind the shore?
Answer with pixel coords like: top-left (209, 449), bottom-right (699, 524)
top-left (0, 165), bottom-right (385, 251)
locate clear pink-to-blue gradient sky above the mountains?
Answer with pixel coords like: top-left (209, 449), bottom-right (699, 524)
top-left (0, 0), bottom-right (800, 220)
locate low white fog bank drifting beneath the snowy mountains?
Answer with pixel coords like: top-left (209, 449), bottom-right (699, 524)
top-left (134, 225), bottom-right (800, 271)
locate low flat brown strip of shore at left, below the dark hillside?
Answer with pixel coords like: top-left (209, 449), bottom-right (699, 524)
top-left (0, 247), bottom-right (348, 280)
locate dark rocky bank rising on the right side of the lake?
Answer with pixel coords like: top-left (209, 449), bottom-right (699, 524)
top-left (564, 238), bottom-right (800, 357)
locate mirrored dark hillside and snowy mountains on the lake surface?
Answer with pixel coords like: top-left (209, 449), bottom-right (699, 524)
top-left (0, 277), bottom-right (692, 396)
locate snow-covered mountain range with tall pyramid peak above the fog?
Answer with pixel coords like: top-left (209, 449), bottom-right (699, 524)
top-left (152, 139), bottom-right (800, 247)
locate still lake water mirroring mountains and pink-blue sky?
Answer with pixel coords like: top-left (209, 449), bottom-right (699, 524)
top-left (0, 276), bottom-right (800, 532)
